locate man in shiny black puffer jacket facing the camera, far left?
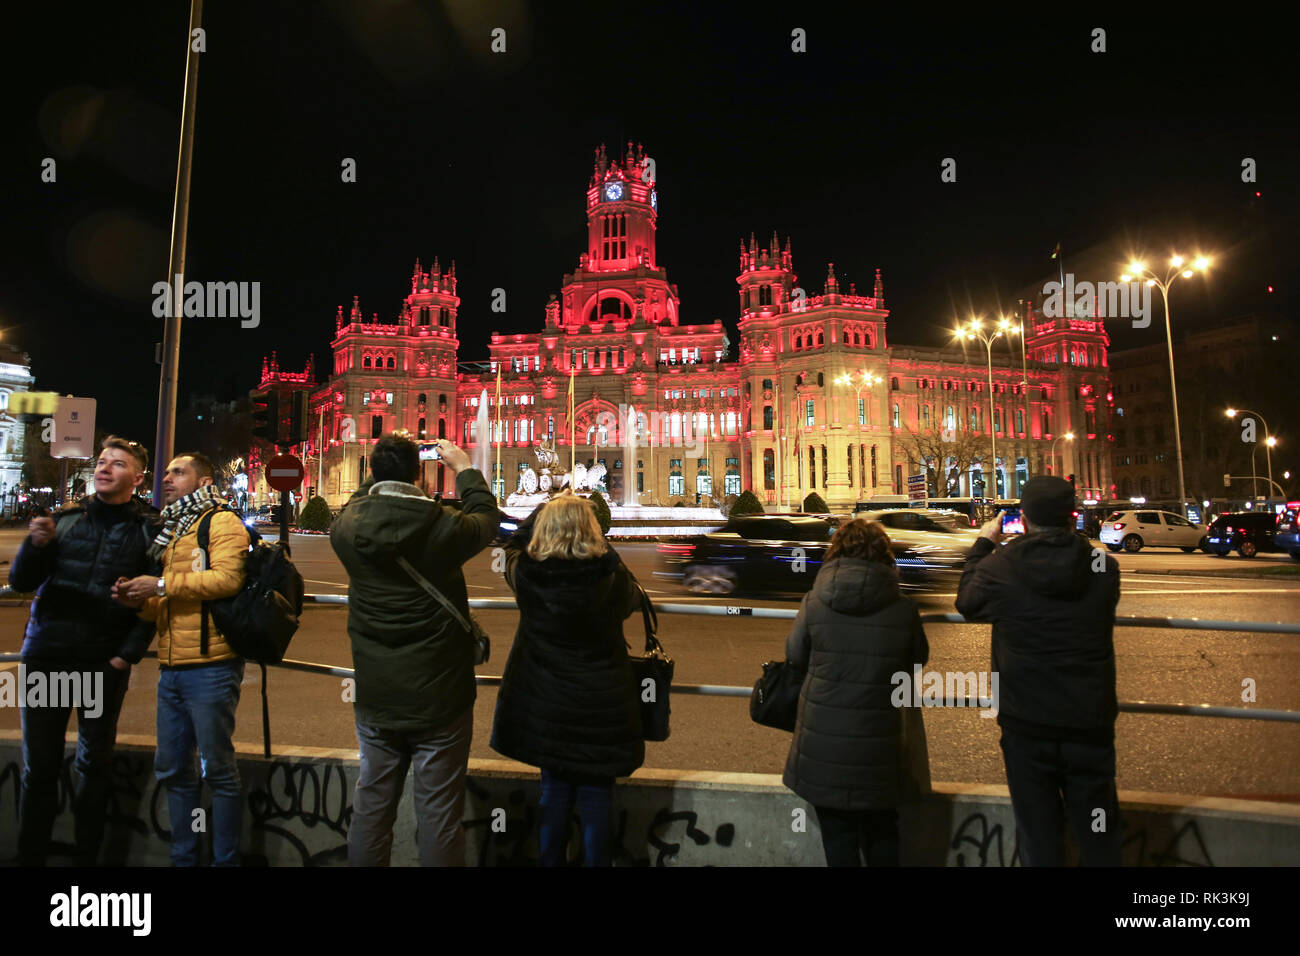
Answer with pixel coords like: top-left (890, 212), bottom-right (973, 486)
top-left (9, 437), bottom-right (157, 866)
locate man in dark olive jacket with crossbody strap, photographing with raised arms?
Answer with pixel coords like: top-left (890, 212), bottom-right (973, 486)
top-left (329, 434), bottom-right (501, 866)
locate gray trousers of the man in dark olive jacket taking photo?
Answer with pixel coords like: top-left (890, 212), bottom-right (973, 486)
top-left (347, 706), bottom-right (475, 866)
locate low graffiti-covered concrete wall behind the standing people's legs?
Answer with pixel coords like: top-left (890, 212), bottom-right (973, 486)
top-left (0, 731), bottom-right (1300, 866)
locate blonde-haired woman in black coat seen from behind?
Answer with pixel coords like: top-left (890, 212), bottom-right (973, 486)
top-left (491, 494), bottom-right (645, 866)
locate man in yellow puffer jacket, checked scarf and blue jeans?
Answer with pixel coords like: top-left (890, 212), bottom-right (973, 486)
top-left (114, 453), bottom-right (248, 866)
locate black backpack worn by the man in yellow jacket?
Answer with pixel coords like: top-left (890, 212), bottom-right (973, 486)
top-left (199, 509), bottom-right (303, 663)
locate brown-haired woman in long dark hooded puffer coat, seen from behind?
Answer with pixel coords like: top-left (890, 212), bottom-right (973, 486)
top-left (784, 519), bottom-right (930, 866)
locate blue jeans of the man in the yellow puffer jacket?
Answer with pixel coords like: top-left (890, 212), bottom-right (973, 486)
top-left (153, 658), bottom-right (244, 866)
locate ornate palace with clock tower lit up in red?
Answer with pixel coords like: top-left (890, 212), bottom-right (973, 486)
top-left (250, 143), bottom-right (1113, 509)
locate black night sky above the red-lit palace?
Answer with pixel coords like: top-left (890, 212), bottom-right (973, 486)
top-left (0, 0), bottom-right (1300, 445)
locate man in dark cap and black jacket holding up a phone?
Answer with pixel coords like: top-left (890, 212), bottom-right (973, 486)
top-left (957, 476), bottom-right (1121, 866)
